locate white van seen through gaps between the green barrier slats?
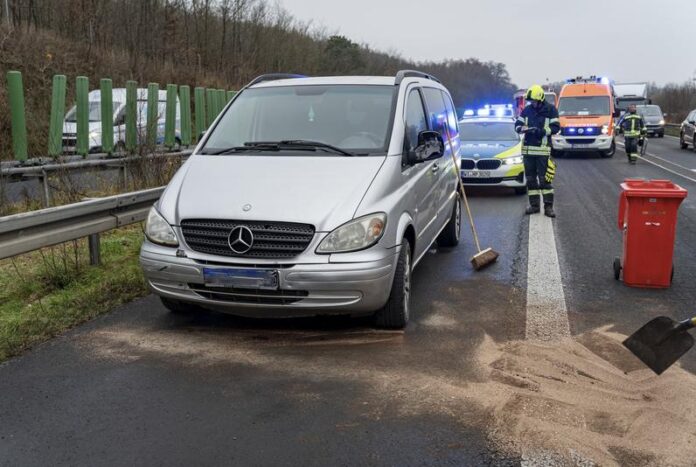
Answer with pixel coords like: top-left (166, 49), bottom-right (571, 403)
top-left (63, 88), bottom-right (181, 154)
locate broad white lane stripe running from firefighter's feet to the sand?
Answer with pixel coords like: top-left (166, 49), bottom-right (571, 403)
top-left (525, 214), bottom-right (570, 342)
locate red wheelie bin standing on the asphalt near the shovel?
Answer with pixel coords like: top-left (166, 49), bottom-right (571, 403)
top-left (614, 179), bottom-right (687, 288)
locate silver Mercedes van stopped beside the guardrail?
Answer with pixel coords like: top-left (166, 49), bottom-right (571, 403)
top-left (140, 71), bottom-right (461, 328)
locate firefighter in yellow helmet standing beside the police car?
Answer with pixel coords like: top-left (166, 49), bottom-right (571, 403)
top-left (515, 84), bottom-right (561, 217)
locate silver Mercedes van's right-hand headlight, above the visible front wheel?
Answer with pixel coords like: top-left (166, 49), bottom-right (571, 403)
top-left (317, 212), bottom-right (387, 254)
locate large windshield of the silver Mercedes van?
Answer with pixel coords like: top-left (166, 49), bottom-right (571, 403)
top-left (201, 85), bottom-right (397, 155)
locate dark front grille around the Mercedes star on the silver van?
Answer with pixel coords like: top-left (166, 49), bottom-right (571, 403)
top-left (181, 219), bottom-right (314, 259)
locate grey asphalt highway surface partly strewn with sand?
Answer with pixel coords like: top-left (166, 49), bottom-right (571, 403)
top-left (0, 137), bottom-right (696, 466)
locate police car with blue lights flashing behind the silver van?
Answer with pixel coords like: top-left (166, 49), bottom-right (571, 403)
top-left (459, 106), bottom-right (527, 194)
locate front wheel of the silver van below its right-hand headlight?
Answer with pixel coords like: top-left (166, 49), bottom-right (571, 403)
top-left (375, 238), bottom-right (411, 329)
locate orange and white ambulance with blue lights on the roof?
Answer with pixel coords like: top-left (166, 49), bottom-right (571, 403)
top-left (551, 76), bottom-right (619, 157)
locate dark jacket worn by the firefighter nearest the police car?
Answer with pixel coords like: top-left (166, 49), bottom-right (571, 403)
top-left (515, 102), bottom-right (561, 156)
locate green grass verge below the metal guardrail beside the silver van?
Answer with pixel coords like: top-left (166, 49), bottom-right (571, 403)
top-left (0, 224), bottom-right (147, 362)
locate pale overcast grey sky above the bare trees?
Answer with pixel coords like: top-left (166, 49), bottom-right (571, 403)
top-left (278, 0), bottom-right (696, 87)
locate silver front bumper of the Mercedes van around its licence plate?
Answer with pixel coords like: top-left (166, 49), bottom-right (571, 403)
top-left (140, 241), bottom-right (400, 318)
